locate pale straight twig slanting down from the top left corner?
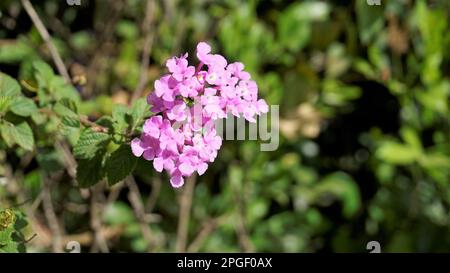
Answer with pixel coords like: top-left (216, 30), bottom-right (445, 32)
top-left (21, 0), bottom-right (70, 83)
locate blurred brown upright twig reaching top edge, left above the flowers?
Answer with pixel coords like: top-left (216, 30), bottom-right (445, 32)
top-left (131, 0), bottom-right (155, 103)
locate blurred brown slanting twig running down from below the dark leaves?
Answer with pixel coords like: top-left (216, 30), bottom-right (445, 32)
top-left (126, 175), bottom-right (153, 251)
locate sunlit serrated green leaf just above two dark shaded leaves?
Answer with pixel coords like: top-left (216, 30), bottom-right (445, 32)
top-left (73, 128), bottom-right (110, 159)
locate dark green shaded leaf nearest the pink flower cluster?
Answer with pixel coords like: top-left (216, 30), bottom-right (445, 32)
top-left (105, 144), bottom-right (137, 185)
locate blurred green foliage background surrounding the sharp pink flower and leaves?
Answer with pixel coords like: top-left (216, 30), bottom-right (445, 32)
top-left (0, 0), bottom-right (450, 252)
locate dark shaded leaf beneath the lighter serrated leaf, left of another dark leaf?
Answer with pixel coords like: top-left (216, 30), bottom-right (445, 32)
top-left (77, 153), bottom-right (104, 188)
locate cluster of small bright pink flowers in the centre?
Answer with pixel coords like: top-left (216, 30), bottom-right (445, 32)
top-left (131, 42), bottom-right (268, 188)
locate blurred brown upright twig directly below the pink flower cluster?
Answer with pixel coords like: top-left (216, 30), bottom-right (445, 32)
top-left (176, 174), bottom-right (197, 253)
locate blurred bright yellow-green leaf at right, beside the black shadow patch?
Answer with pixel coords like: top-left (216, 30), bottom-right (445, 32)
top-left (375, 141), bottom-right (420, 165)
